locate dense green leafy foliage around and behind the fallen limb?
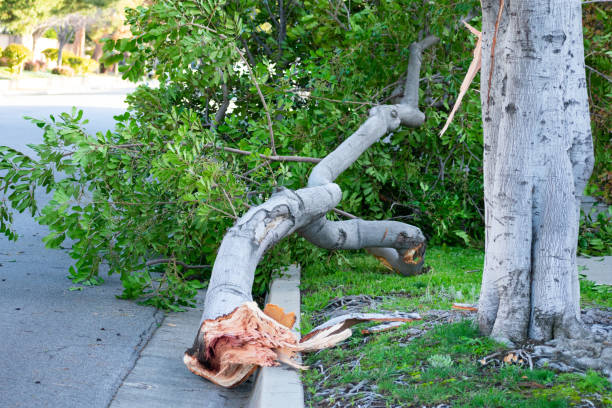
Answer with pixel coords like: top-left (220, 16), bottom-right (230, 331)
top-left (0, 0), bottom-right (608, 307)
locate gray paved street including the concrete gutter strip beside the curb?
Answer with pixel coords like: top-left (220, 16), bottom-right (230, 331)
top-left (0, 91), bottom-right (252, 408)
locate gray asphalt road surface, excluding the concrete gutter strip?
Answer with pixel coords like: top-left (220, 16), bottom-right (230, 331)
top-left (0, 92), bottom-right (170, 408)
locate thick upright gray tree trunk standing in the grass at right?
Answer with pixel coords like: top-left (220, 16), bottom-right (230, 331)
top-left (478, 0), bottom-right (593, 343)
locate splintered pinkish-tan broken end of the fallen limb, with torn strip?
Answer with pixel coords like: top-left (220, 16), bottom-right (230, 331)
top-left (183, 302), bottom-right (421, 387)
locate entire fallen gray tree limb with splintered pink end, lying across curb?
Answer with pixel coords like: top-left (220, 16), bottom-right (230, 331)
top-left (184, 36), bottom-right (438, 387)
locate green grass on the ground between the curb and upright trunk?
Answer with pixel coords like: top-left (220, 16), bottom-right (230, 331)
top-left (301, 247), bottom-right (612, 407)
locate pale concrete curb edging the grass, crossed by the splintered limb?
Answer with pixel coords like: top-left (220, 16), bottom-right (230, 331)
top-left (248, 265), bottom-right (304, 408)
